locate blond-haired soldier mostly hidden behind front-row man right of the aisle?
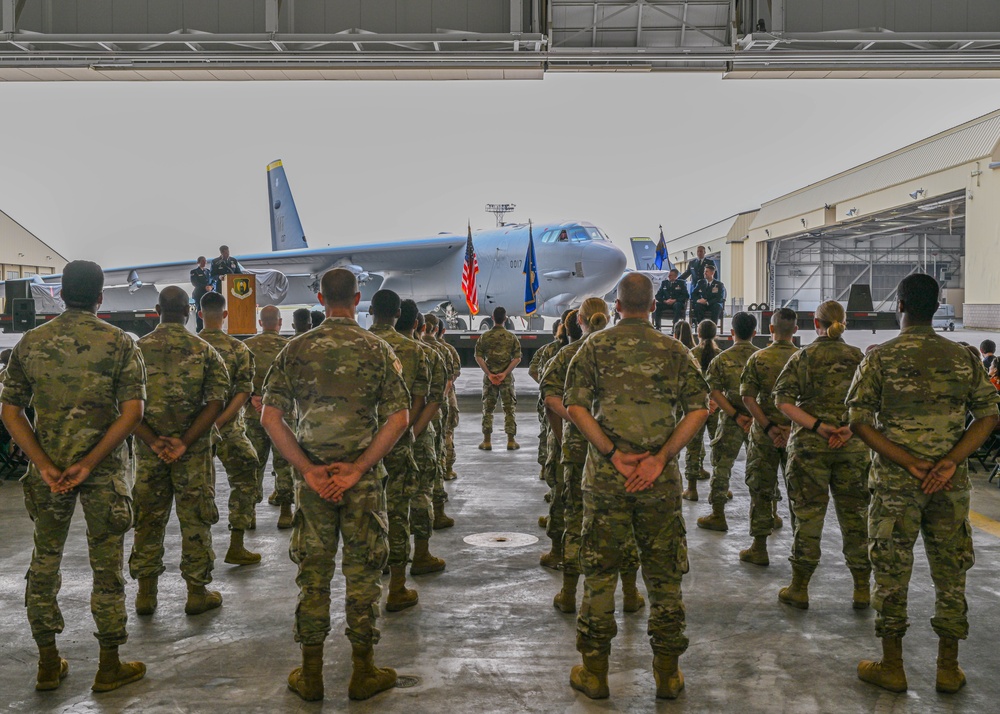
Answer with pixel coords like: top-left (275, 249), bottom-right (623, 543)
top-left (539, 297), bottom-right (646, 613)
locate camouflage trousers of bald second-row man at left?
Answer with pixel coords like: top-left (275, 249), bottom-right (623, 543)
top-left (128, 438), bottom-right (219, 585)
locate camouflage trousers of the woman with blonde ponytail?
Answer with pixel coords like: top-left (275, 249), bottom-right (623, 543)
top-left (785, 449), bottom-right (871, 573)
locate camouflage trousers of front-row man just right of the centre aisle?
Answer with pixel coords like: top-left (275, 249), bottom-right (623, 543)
top-left (576, 468), bottom-right (688, 656)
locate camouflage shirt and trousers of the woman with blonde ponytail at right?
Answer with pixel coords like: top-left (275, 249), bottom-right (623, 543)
top-left (773, 336), bottom-right (871, 579)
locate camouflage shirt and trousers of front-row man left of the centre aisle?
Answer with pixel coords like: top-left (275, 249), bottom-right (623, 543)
top-left (264, 317), bottom-right (410, 647)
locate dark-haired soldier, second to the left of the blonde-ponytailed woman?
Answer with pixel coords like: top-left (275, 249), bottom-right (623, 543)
top-left (688, 312), bottom-right (757, 531)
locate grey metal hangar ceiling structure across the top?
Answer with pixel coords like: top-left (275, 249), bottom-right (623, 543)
top-left (0, 0), bottom-right (1000, 81)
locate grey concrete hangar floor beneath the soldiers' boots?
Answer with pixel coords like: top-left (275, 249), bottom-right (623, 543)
top-left (0, 369), bottom-right (1000, 714)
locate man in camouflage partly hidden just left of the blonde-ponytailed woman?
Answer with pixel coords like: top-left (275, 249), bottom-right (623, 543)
top-left (740, 307), bottom-right (798, 566)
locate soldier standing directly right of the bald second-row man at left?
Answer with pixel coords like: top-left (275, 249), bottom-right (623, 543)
top-left (199, 293), bottom-right (260, 565)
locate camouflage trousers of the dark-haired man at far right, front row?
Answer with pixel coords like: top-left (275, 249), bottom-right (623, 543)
top-left (868, 470), bottom-right (975, 640)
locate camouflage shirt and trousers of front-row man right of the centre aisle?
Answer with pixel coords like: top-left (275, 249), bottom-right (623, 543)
top-left (563, 318), bottom-right (708, 657)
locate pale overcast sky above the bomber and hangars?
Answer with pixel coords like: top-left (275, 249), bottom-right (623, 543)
top-left (0, 74), bottom-right (1000, 267)
